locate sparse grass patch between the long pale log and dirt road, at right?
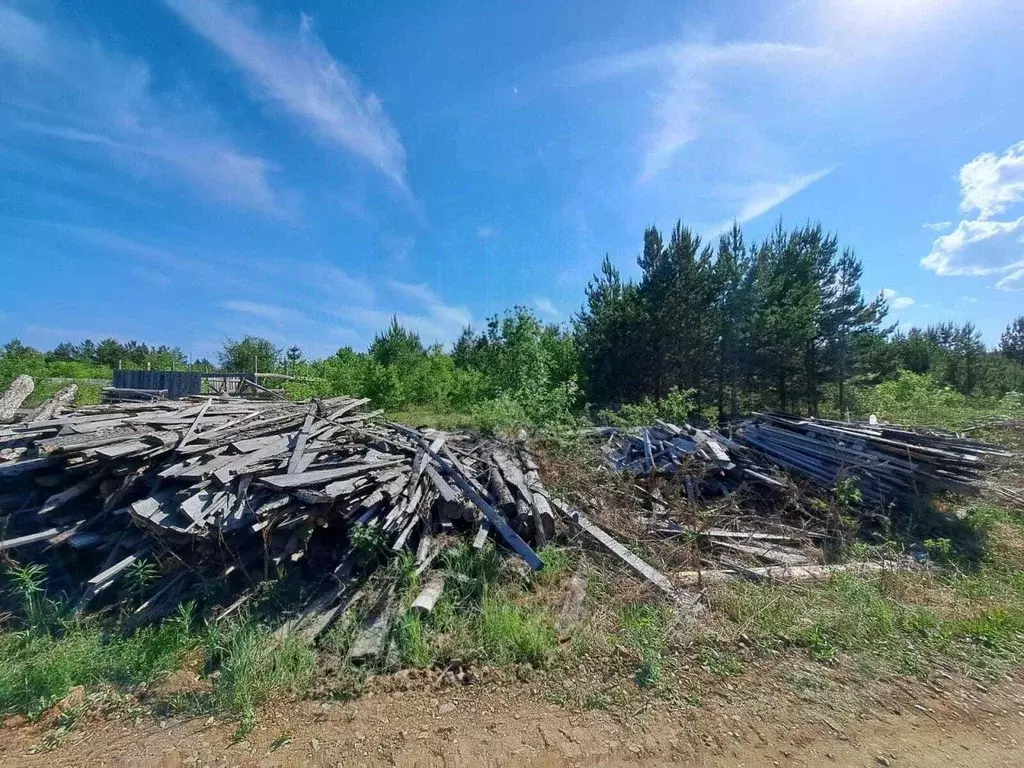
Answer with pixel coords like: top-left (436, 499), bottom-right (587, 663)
top-left (706, 506), bottom-right (1024, 674)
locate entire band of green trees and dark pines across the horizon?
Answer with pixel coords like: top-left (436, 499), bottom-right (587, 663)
top-left (0, 223), bottom-right (1024, 423)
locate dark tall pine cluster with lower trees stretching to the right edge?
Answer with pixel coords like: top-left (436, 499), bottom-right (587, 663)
top-left (573, 219), bottom-right (1024, 415)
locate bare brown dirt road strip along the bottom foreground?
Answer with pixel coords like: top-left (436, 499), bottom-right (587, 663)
top-left (0, 663), bottom-right (1024, 768)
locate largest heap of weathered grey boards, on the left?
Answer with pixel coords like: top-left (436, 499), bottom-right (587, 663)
top-left (0, 397), bottom-right (569, 639)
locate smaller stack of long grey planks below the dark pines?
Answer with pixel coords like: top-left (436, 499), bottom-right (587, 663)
top-left (601, 414), bottom-right (1013, 507)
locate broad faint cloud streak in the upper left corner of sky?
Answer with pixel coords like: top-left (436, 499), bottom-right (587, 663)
top-left (0, 6), bottom-right (288, 215)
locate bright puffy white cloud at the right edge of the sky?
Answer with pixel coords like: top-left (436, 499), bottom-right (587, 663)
top-left (921, 141), bottom-right (1024, 291)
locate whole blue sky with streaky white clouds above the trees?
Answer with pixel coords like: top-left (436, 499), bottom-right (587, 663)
top-left (0, 0), bottom-right (1024, 357)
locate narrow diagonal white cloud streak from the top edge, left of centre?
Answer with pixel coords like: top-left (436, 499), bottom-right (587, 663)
top-left (166, 0), bottom-right (409, 189)
